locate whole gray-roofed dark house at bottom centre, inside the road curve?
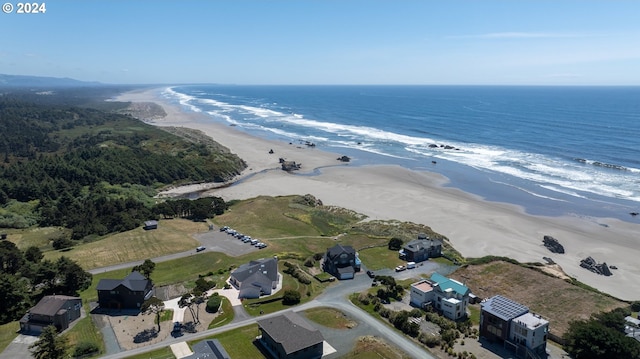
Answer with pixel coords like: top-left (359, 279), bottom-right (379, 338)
top-left (258, 311), bottom-right (324, 359)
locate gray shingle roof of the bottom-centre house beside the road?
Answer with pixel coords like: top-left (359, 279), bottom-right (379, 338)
top-left (258, 311), bottom-right (324, 355)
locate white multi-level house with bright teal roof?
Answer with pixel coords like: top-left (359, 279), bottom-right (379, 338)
top-left (410, 273), bottom-right (471, 320)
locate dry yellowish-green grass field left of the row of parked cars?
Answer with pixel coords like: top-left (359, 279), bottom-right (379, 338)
top-left (44, 219), bottom-right (208, 269)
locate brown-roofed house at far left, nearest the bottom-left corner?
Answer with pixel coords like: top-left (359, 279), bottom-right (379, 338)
top-left (20, 295), bottom-right (82, 333)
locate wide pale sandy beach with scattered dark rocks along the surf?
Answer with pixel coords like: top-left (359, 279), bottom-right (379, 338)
top-left (116, 89), bottom-right (640, 301)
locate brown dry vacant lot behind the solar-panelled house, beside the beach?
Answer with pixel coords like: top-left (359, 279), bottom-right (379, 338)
top-left (451, 261), bottom-right (627, 335)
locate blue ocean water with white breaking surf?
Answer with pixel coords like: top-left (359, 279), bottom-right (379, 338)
top-left (163, 85), bottom-right (640, 223)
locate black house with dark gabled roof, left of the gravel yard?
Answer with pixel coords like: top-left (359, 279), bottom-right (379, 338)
top-left (96, 271), bottom-right (153, 309)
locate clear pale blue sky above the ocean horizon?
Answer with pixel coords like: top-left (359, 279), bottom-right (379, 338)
top-left (0, 0), bottom-right (640, 85)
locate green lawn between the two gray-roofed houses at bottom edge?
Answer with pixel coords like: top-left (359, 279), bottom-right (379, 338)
top-left (196, 324), bottom-right (265, 359)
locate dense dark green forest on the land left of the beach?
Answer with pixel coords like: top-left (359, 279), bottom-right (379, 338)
top-left (0, 92), bottom-right (246, 239)
